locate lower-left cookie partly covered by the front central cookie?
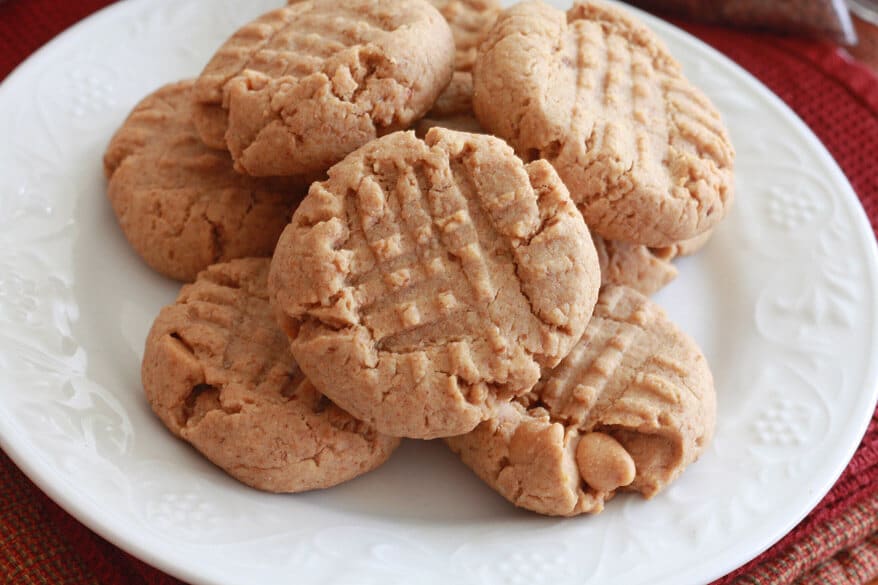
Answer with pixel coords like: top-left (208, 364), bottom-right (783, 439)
top-left (142, 258), bottom-right (399, 492)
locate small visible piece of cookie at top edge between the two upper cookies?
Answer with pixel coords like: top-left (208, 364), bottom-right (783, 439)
top-left (429, 0), bottom-right (502, 71)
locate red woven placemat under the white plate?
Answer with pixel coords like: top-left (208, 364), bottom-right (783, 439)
top-left (0, 0), bottom-right (878, 585)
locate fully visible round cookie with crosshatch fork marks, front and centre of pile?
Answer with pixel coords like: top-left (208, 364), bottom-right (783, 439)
top-left (269, 128), bottom-right (600, 438)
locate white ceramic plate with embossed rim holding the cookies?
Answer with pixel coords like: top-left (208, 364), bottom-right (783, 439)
top-left (0, 0), bottom-right (878, 585)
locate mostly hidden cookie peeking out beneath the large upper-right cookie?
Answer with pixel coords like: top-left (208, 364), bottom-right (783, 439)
top-left (592, 236), bottom-right (677, 296)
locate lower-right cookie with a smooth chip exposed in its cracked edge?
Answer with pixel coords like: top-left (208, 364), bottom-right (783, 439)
top-left (447, 286), bottom-right (716, 516)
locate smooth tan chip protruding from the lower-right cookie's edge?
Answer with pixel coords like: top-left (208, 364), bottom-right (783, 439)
top-left (576, 433), bottom-right (637, 492)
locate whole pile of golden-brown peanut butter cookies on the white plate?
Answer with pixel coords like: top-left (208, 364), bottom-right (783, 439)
top-left (104, 0), bottom-right (734, 516)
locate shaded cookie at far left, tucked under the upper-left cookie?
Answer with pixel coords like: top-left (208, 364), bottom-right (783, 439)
top-left (104, 80), bottom-right (307, 281)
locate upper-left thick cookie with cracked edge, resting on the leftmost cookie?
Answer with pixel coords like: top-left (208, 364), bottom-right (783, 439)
top-left (194, 0), bottom-right (454, 176)
